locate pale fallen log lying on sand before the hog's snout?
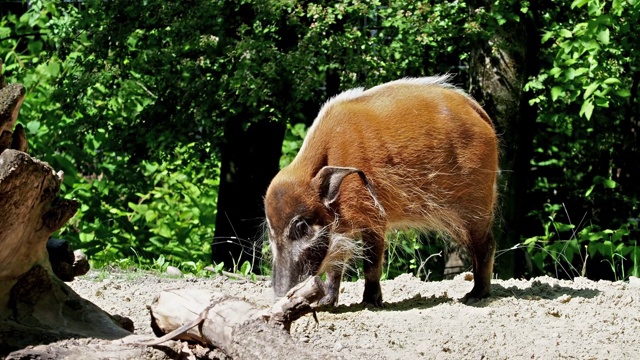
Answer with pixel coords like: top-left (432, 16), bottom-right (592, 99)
top-left (141, 276), bottom-right (331, 359)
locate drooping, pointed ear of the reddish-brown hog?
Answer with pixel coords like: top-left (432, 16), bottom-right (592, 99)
top-left (313, 166), bottom-right (384, 213)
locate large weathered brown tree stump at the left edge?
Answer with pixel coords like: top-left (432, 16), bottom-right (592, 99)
top-left (0, 64), bottom-right (130, 356)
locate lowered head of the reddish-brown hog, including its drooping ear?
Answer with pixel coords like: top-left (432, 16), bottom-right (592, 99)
top-left (265, 166), bottom-right (377, 297)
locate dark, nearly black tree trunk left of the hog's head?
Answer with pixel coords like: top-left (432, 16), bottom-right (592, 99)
top-left (211, 118), bottom-right (285, 273)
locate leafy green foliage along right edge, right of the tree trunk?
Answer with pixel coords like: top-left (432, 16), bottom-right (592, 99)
top-left (525, 0), bottom-right (640, 278)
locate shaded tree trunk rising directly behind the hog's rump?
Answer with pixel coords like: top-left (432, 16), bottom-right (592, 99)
top-left (469, 0), bottom-right (540, 278)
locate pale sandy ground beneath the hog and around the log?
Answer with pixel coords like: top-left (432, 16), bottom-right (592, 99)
top-left (48, 272), bottom-right (640, 359)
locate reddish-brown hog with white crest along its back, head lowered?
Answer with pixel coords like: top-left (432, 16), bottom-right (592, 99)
top-left (265, 77), bottom-right (498, 305)
